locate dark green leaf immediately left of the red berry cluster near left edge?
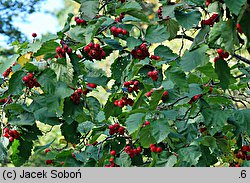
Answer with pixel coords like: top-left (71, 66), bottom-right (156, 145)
top-left (8, 71), bottom-right (25, 95)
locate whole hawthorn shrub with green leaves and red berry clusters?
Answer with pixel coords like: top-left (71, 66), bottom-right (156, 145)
top-left (0, 0), bottom-right (250, 167)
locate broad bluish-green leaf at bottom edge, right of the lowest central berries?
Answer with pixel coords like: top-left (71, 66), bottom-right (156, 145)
top-left (178, 146), bottom-right (202, 166)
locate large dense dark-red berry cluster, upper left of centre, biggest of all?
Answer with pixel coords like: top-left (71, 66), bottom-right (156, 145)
top-left (83, 42), bottom-right (106, 60)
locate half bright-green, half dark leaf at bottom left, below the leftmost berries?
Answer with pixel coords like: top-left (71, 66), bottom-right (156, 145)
top-left (10, 138), bottom-right (33, 167)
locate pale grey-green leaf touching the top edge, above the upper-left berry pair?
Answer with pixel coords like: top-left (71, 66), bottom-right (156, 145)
top-left (79, 0), bottom-right (99, 20)
